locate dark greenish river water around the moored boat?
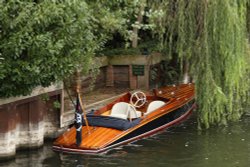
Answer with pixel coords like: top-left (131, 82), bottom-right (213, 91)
top-left (0, 115), bottom-right (250, 167)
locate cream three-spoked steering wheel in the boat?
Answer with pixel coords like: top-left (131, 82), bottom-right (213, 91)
top-left (130, 91), bottom-right (147, 108)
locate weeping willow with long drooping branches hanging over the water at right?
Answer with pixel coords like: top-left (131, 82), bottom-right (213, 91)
top-left (147, 0), bottom-right (250, 128)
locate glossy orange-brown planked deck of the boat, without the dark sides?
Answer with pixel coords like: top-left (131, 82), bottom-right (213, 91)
top-left (53, 84), bottom-right (194, 153)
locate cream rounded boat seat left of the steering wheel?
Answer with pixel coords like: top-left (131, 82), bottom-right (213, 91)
top-left (110, 102), bottom-right (130, 119)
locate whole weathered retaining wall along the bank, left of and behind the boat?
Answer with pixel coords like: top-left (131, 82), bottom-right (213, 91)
top-left (0, 54), bottom-right (163, 159)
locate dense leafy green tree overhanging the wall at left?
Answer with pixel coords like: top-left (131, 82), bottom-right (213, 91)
top-left (0, 0), bottom-right (133, 97)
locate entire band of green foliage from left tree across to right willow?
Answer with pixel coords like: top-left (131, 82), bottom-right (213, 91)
top-left (0, 0), bottom-right (250, 128)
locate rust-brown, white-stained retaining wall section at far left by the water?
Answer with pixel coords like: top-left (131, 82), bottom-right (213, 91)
top-left (0, 90), bottom-right (61, 159)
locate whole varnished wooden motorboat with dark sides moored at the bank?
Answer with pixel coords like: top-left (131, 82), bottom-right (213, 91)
top-left (53, 83), bottom-right (195, 154)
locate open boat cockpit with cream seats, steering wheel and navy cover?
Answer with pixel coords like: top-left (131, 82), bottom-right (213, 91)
top-left (83, 91), bottom-right (166, 130)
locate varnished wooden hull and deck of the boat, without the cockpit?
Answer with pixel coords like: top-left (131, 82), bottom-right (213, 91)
top-left (53, 84), bottom-right (195, 154)
